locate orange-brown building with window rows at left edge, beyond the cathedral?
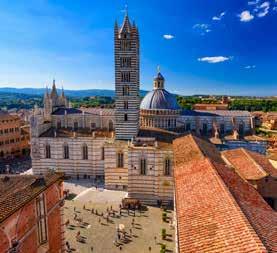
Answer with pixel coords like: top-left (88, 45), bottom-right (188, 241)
top-left (0, 110), bottom-right (30, 159)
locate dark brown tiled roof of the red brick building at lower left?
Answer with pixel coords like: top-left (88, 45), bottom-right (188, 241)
top-left (0, 173), bottom-right (63, 223)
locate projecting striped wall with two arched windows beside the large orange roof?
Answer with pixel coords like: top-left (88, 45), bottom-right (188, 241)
top-left (128, 147), bottom-right (173, 204)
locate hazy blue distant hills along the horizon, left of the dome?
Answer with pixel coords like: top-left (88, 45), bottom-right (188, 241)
top-left (0, 87), bottom-right (147, 98)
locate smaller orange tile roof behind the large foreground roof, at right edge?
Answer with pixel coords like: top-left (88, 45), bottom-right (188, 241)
top-left (222, 148), bottom-right (277, 180)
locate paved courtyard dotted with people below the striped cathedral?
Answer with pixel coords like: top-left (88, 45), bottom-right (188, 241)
top-left (64, 180), bottom-right (175, 253)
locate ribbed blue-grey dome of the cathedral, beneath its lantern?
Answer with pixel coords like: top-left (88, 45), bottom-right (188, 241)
top-left (140, 89), bottom-right (180, 110)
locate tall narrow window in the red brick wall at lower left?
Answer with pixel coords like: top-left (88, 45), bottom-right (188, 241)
top-left (36, 195), bottom-right (47, 245)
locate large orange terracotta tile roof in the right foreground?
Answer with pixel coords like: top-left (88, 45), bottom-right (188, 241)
top-left (173, 135), bottom-right (277, 253)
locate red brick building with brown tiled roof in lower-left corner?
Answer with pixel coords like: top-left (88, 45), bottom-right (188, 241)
top-left (0, 173), bottom-right (65, 253)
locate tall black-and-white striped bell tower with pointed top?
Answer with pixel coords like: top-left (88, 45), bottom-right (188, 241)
top-left (114, 11), bottom-right (140, 140)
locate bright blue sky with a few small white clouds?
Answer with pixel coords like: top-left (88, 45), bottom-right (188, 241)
top-left (0, 0), bottom-right (277, 95)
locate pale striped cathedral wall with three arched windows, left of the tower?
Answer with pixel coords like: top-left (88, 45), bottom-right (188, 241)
top-left (32, 136), bottom-right (108, 177)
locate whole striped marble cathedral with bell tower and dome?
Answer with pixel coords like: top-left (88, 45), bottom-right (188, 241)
top-left (31, 14), bottom-right (253, 203)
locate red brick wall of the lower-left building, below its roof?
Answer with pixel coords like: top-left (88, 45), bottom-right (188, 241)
top-left (0, 182), bottom-right (64, 253)
